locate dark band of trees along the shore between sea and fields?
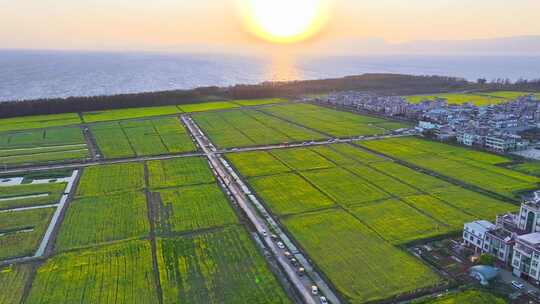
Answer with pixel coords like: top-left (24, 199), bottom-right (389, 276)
top-left (5, 74), bottom-right (540, 118)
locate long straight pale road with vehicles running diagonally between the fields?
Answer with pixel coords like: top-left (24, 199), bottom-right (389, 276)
top-left (182, 116), bottom-right (340, 304)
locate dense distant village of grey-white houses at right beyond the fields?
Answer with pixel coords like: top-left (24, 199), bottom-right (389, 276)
top-left (324, 92), bottom-right (540, 153)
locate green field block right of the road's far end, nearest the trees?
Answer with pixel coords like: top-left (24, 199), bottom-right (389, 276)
top-left (193, 110), bottom-right (324, 148)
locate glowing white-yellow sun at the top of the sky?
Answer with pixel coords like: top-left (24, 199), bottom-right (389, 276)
top-left (241, 0), bottom-right (329, 43)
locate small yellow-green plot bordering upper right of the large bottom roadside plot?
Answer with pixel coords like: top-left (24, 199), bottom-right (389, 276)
top-left (352, 200), bottom-right (450, 244)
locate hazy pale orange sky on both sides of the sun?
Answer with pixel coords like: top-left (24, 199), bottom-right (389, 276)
top-left (0, 0), bottom-right (540, 50)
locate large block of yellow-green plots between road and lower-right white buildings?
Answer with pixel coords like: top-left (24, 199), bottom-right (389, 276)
top-left (227, 144), bottom-right (517, 303)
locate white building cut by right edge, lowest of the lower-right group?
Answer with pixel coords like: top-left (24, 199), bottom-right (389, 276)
top-left (512, 232), bottom-right (540, 284)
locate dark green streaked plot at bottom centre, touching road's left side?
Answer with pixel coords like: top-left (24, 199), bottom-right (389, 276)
top-left (158, 227), bottom-right (291, 304)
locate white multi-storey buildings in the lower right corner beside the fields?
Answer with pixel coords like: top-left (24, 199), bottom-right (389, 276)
top-left (463, 192), bottom-right (540, 285)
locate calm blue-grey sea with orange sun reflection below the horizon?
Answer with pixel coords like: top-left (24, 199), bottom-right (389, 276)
top-left (0, 50), bottom-right (540, 101)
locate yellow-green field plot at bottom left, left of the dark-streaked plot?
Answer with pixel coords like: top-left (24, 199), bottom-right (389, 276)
top-left (27, 241), bottom-right (158, 304)
